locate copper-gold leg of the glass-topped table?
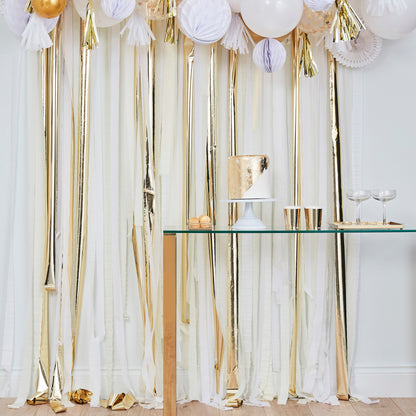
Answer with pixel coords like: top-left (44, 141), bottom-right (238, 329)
top-left (163, 233), bottom-right (176, 416)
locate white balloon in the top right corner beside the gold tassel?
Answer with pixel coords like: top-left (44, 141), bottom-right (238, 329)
top-left (362, 0), bottom-right (416, 40)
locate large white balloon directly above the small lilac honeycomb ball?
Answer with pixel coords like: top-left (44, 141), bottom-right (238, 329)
top-left (241, 0), bottom-right (303, 38)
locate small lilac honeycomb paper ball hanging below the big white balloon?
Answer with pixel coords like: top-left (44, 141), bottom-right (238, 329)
top-left (253, 38), bottom-right (286, 73)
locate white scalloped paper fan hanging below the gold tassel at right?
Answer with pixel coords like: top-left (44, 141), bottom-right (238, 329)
top-left (325, 29), bottom-right (383, 68)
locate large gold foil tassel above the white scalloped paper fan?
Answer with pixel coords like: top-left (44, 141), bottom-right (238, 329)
top-left (331, 0), bottom-right (365, 42)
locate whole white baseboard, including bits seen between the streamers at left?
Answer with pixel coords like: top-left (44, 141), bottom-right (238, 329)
top-left (0, 365), bottom-right (416, 397)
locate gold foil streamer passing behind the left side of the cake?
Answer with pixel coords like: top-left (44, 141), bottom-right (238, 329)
top-left (227, 50), bottom-right (239, 407)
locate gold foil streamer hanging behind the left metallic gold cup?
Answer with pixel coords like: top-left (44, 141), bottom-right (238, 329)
top-left (289, 28), bottom-right (301, 397)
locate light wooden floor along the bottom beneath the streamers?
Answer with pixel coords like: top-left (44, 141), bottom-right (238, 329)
top-left (0, 398), bottom-right (416, 416)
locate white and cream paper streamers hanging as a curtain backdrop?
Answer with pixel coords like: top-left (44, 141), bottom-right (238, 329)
top-left (0, 3), bottom-right (414, 407)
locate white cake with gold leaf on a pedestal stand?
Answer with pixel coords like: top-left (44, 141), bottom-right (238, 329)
top-left (228, 155), bottom-right (271, 199)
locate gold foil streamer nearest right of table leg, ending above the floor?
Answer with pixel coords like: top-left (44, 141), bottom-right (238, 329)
top-left (181, 37), bottom-right (194, 324)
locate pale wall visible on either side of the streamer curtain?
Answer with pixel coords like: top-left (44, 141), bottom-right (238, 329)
top-left (0, 17), bottom-right (416, 397)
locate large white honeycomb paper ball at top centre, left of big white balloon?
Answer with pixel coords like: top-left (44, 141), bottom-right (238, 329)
top-left (177, 0), bottom-right (231, 44)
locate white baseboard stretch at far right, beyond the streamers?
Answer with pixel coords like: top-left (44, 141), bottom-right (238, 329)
top-left (351, 365), bottom-right (416, 397)
